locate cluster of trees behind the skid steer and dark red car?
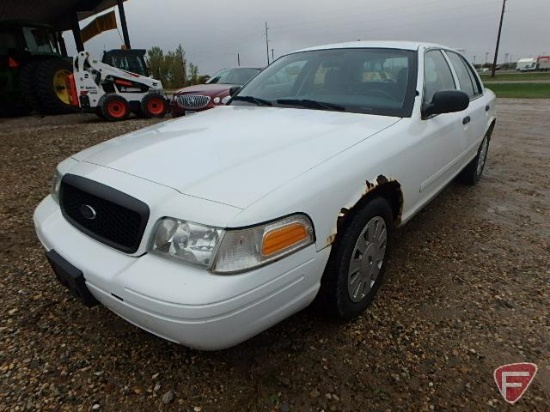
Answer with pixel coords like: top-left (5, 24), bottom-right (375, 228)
top-left (147, 44), bottom-right (209, 89)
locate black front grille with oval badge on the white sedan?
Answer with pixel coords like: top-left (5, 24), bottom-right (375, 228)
top-left (59, 174), bottom-right (149, 253)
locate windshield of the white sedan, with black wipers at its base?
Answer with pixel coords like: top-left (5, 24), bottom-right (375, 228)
top-left (231, 48), bottom-right (417, 117)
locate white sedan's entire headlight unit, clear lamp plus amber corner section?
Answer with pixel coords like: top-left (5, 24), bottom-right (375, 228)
top-left (152, 214), bottom-right (315, 274)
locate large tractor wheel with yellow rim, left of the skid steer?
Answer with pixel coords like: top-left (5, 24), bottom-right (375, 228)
top-left (34, 59), bottom-right (74, 114)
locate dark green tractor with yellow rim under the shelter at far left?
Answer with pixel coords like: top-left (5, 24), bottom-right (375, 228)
top-left (0, 20), bottom-right (73, 116)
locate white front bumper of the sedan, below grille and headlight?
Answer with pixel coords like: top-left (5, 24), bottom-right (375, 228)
top-left (34, 196), bottom-right (330, 350)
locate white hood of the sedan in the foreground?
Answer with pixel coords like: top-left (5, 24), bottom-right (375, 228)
top-left (73, 106), bottom-right (400, 209)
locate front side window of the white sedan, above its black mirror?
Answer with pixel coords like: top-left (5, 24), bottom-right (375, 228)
top-left (424, 50), bottom-right (456, 103)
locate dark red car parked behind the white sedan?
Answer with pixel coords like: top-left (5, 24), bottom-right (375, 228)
top-left (170, 67), bottom-right (262, 117)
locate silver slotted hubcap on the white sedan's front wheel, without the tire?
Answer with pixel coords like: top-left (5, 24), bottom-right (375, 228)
top-left (348, 216), bottom-right (388, 302)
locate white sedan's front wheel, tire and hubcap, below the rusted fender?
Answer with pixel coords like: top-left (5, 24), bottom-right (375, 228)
top-left (318, 197), bottom-right (393, 320)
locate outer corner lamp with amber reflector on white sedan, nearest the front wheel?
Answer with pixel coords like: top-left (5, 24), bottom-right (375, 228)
top-left (212, 214), bottom-right (315, 274)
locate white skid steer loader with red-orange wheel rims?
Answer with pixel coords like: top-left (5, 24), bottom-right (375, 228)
top-left (68, 51), bottom-right (168, 121)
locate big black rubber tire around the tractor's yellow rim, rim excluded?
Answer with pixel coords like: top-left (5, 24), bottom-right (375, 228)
top-left (35, 59), bottom-right (74, 114)
